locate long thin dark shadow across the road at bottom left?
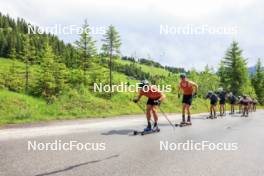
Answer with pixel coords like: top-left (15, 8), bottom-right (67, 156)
top-left (35, 155), bottom-right (119, 176)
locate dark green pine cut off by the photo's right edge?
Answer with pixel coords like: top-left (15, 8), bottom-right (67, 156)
top-left (252, 59), bottom-right (264, 104)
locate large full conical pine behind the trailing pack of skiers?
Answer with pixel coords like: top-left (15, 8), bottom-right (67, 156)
top-left (219, 41), bottom-right (251, 95)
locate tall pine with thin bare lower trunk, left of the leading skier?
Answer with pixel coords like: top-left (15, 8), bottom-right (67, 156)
top-left (102, 25), bottom-right (121, 97)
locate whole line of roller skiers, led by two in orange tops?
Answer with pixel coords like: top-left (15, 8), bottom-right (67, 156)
top-left (134, 73), bottom-right (258, 132)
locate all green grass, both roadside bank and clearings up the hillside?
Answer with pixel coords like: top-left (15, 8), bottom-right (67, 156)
top-left (0, 58), bottom-right (260, 125)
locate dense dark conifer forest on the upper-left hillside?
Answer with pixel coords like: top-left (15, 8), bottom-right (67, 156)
top-left (0, 13), bottom-right (78, 67)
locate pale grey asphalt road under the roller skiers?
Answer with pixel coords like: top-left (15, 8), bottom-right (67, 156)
top-left (0, 111), bottom-right (264, 176)
